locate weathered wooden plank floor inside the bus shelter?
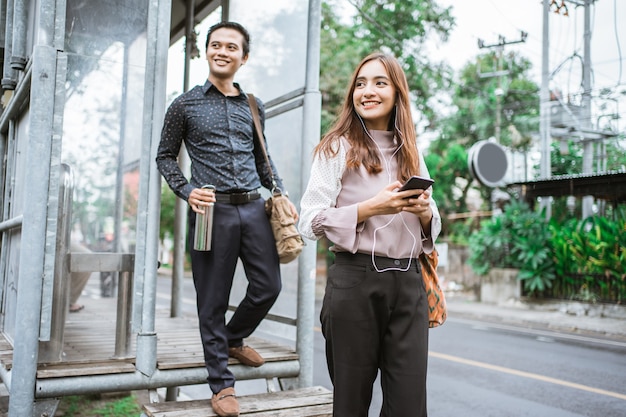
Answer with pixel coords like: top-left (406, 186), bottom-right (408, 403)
top-left (0, 298), bottom-right (298, 378)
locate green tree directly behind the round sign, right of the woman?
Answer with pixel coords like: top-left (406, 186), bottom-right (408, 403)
top-left (426, 52), bottom-right (539, 218)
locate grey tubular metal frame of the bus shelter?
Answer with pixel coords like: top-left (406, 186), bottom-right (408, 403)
top-left (0, 0), bottom-right (321, 417)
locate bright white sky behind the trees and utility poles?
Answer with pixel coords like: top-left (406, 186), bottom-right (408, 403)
top-left (168, 0), bottom-right (626, 130)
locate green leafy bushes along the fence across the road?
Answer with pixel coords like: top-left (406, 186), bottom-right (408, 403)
top-left (468, 198), bottom-right (626, 303)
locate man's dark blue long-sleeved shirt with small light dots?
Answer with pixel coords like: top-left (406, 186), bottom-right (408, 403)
top-left (156, 81), bottom-right (284, 200)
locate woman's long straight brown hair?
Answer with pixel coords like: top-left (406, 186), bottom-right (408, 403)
top-left (314, 52), bottom-right (420, 181)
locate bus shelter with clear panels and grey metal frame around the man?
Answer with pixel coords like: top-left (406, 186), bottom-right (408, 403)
top-left (0, 0), bottom-right (321, 417)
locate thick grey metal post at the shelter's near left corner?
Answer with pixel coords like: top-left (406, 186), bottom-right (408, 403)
top-left (9, 45), bottom-right (56, 417)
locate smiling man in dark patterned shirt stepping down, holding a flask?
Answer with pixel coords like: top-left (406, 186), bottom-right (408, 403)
top-left (156, 22), bottom-right (296, 416)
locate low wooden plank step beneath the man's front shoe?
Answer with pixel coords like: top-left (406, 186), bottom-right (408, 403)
top-left (142, 387), bottom-right (333, 417)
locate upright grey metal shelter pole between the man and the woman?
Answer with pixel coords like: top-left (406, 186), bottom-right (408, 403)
top-left (296, 0), bottom-right (322, 387)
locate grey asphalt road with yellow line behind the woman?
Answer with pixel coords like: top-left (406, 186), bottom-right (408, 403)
top-left (152, 277), bottom-right (626, 417)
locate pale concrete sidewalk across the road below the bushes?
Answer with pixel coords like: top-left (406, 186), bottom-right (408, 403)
top-left (446, 292), bottom-right (626, 341)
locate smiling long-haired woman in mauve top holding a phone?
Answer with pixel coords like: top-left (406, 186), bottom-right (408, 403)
top-left (299, 53), bottom-right (441, 417)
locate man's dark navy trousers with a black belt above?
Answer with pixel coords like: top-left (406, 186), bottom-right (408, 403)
top-left (188, 198), bottom-right (282, 393)
